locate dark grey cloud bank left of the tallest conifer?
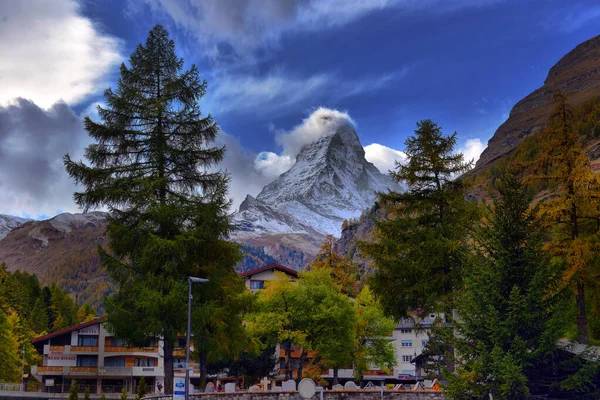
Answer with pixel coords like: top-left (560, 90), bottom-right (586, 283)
top-left (0, 99), bottom-right (89, 218)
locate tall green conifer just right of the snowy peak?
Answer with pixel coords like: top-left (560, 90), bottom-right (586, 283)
top-left (360, 120), bottom-right (472, 317)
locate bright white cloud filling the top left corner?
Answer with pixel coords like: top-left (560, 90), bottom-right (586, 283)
top-left (0, 0), bottom-right (122, 108)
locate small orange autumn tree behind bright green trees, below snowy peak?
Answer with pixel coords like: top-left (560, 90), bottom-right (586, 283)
top-left (309, 235), bottom-right (360, 297)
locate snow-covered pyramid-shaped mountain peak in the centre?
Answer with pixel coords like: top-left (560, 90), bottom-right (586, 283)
top-left (234, 116), bottom-right (393, 237)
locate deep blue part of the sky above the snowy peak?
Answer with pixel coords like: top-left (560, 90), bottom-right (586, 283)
top-left (79, 0), bottom-right (600, 152)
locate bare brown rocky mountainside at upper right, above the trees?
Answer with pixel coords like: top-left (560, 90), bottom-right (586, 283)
top-left (475, 36), bottom-right (600, 170)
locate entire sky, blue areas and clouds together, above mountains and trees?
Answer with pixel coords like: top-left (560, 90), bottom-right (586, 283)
top-left (0, 0), bottom-right (600, 216)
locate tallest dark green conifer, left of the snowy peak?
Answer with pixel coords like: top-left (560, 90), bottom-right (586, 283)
top-left (64, 25), bottom-right (244, 393)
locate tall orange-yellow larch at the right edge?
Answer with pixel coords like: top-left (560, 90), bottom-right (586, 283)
top-left (529, 92), bottom-right (600, 344)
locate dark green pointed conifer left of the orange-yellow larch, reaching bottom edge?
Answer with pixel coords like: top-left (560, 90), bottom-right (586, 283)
top-left (445, 174), bottom-right (596, 399)
